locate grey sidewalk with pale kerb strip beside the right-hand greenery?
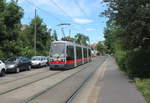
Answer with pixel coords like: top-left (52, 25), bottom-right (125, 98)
top-left (73, 57), bottom-right (146, 103)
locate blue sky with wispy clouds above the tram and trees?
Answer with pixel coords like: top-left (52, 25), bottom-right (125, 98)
top-left (18, 0), bottom-right (107, 43)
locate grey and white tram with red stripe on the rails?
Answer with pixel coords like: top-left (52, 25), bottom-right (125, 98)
top-left (49, 41), bottom-right (91, 70)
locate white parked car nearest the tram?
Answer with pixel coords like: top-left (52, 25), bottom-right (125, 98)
top-left (31, 56), bottom-right (48, 67)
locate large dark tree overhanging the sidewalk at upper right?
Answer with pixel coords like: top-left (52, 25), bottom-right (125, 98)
top-left (103, 0), bottom-right (150, 49)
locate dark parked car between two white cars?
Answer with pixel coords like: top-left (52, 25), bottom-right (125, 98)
top-left (5, 57), bottom-right (31, 73)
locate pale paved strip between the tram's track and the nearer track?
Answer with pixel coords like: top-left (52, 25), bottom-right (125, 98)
top-left (0, 63), bottom-right (92, 103)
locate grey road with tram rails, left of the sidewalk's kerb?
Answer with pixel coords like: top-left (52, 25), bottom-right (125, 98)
top-left (0, 57), bottom-right (107, 103)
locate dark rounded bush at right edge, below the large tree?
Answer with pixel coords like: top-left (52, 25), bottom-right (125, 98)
top-left (125, 49), bottom-right (150, 78)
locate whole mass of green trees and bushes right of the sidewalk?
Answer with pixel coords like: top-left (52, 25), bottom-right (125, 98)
top-left (103, 0), bottom-right (150, 77)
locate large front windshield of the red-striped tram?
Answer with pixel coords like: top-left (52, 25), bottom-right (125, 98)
top-left (50, 43), bottom-right (65, 58)
